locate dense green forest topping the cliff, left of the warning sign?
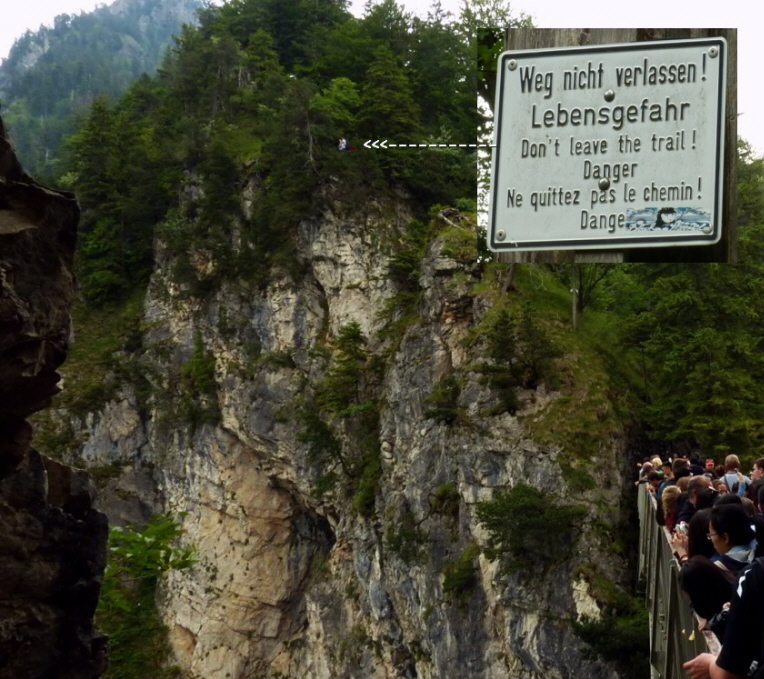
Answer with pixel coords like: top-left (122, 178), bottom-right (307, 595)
top-left (58, 0), bottom-right (476, 305)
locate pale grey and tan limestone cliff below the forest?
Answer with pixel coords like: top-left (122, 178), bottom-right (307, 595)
top-left (49, 189), bottom-right (628, 679)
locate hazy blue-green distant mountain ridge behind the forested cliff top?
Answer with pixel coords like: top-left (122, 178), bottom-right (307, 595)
top-left (0, 0), bottom-right (203, 178)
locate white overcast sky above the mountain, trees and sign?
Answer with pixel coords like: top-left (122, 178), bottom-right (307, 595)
top-left (0, 0), bottom-right (764, 155)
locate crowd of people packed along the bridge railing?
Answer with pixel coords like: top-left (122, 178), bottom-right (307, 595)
top-left (637, 455), bottom-right (764, 679)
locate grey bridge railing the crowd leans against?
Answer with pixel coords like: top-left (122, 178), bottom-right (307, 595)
top-left (639, 484), bottom-right (719, 679)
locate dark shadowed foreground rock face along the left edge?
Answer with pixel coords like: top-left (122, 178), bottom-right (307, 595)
top-left (0, 121), bottom-right (107, 679)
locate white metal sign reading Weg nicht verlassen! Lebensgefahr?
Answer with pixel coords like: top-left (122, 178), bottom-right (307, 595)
top-left (488, 38), bottom-right (727, 251)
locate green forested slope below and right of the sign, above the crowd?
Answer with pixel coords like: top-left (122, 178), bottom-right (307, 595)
top-left (594, 142), bottom-right (764, 462)
